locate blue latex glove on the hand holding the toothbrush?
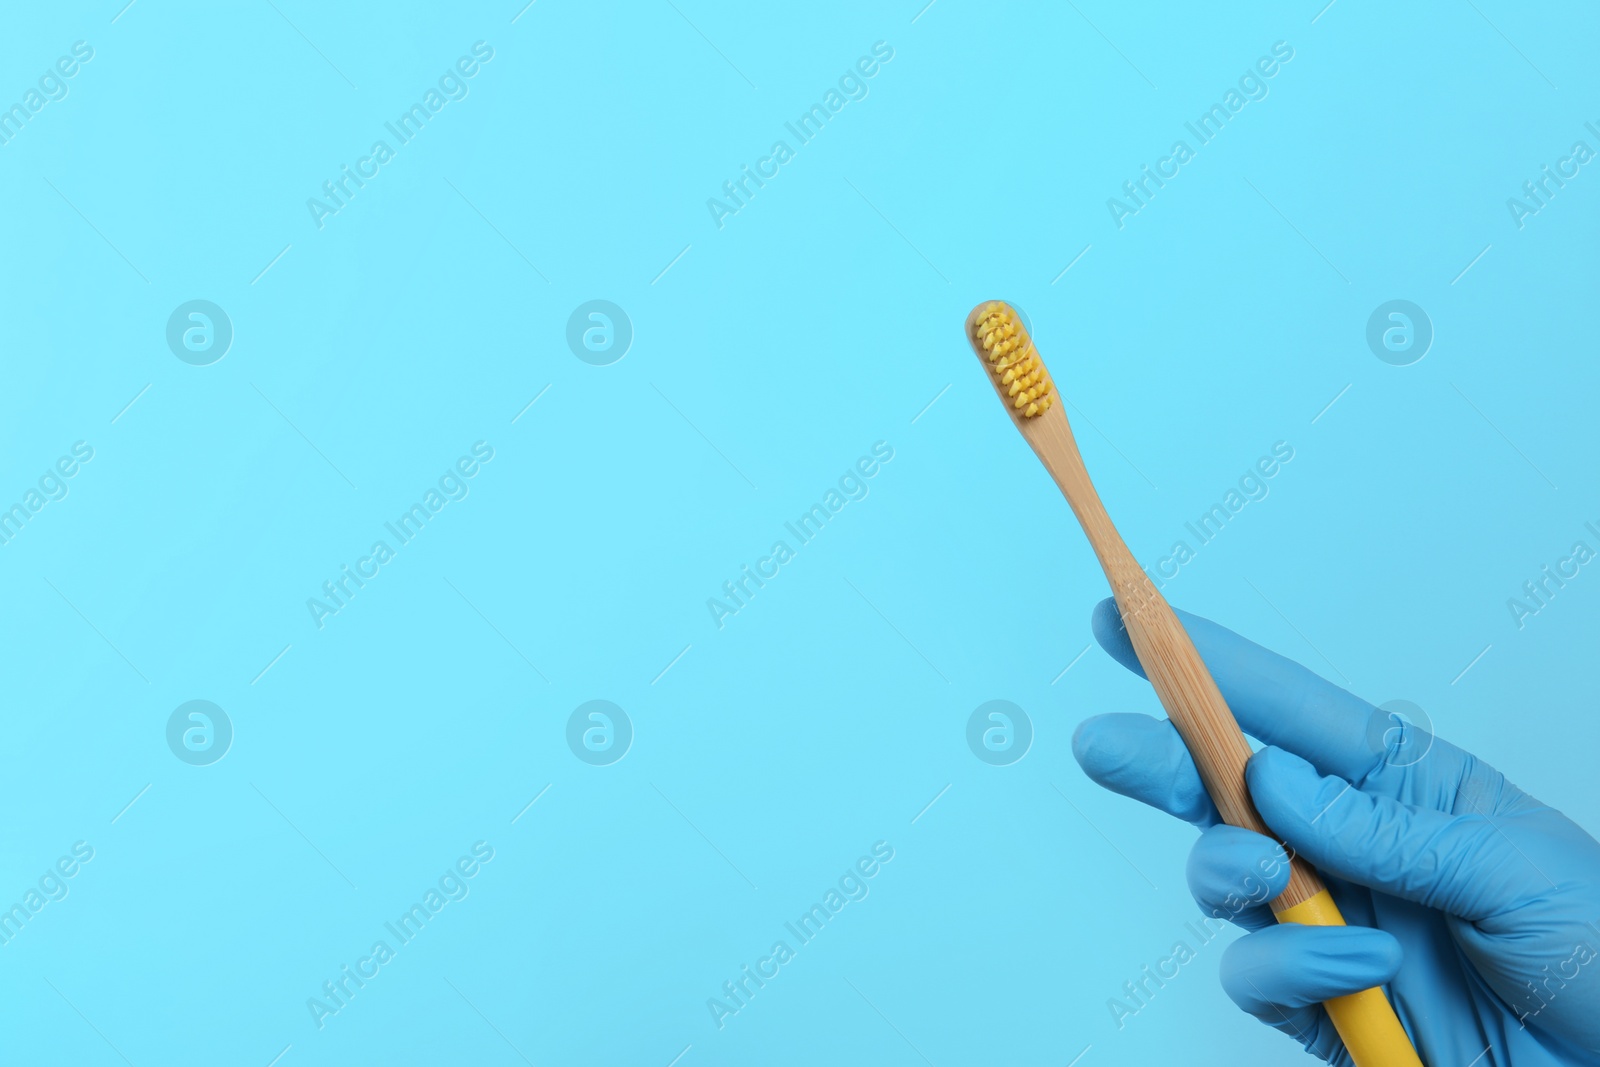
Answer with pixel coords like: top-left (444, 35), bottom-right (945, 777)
top-left (1072, 600), bottom-right (1600, 1067)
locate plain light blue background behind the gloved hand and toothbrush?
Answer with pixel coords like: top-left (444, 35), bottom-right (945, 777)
top-left (0, 0), bottom-right (1600, 1067)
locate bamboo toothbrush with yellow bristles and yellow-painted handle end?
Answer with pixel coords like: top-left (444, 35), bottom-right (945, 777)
top-left (966, 301), bottom-right (1422, 1067)
